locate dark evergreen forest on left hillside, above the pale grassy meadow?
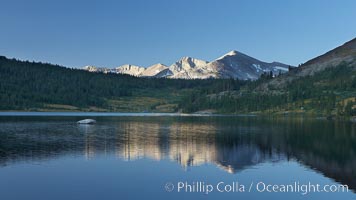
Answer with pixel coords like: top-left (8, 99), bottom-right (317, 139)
top-left (0, 56), bottom-right (242, 110)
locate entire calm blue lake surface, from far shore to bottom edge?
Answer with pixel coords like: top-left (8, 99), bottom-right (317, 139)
top-left (0, 113), bottom-right (356, 200)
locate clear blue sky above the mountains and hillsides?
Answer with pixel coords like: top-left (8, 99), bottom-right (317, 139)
top-left (0, 0), bottom-right (356, 67)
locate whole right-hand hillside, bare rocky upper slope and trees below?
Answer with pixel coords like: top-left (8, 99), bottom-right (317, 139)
top-left (181, 38), bottom-right (356, 117)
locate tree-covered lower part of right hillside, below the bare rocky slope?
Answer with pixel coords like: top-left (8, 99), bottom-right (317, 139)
top-left (181, 62), bottom-right (356, 116)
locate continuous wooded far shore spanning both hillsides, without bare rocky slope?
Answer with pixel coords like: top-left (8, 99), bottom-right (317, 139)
top-left (0, 47), bottom-right (356, 116)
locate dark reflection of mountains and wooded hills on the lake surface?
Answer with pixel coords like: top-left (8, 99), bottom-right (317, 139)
top-left (0, 117), bottom-right (356, 189)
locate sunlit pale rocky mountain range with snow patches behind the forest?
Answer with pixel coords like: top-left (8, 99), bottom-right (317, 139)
top-left (84, 51), bottom-right (289, 80)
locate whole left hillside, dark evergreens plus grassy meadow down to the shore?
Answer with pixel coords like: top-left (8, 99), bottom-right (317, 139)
top-left (0, 56), bottom-right (243, 112)
